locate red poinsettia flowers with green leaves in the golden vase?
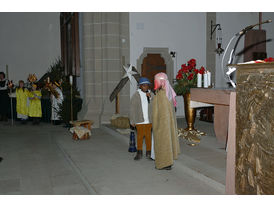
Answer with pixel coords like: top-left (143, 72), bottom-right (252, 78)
top-left (174, 59), bottom-right (205, 95)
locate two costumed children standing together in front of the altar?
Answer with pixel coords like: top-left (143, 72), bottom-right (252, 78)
top-left (130, 73), bottom-right (180, 170)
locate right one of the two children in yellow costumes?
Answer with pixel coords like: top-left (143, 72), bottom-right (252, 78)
top-left (29, 84), bottom-right (42, 124)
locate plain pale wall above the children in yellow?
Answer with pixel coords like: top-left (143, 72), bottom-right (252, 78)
top-left (0, 12), bottom-right (61, 83)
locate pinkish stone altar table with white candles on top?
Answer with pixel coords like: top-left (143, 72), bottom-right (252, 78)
top-left (190, 88), bottom-right (236, 195)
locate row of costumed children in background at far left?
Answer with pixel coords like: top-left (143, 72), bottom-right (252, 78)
top-left (0, 72), bottom-right (63, 125)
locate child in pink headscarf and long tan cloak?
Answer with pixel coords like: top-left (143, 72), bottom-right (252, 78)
top-left (152, 73), bottom-right (180, 170)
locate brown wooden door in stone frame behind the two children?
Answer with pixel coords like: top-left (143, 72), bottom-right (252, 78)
top-left (141, 54), bottom-right (166, 90)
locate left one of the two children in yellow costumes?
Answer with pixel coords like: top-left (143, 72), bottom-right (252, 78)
top-left (16, 80), bottom-right (29, 124)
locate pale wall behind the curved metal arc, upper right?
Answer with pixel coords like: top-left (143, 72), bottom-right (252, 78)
top-left (215, 12), bottom-right (274, 87)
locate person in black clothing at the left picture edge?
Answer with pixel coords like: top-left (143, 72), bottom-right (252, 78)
top-left (0, 72), bottom-right (9, 121)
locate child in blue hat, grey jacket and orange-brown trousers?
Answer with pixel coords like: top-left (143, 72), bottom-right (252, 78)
top-left (130, 77), bottom-right (152, 160)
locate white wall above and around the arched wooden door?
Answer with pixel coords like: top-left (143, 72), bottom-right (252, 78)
top-left (129, 12), bottom-right (206, 116)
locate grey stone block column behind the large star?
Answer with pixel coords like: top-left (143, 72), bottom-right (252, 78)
top-left (79, 12), bottom-right (130, 127)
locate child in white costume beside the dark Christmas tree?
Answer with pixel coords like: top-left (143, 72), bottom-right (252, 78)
top-left (50, 82), bottom-right (64, 125)
